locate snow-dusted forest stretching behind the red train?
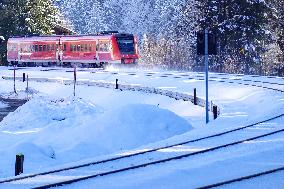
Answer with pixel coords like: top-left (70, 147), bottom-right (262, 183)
top-left (0, 0), bottom-right (284, 76)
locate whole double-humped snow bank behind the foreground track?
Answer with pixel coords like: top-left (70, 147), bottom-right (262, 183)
top-left (0, 97), bottom-right (192, 177)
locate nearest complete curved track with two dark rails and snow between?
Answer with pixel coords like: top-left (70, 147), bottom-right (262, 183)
top-left (0, 114), bottom-right (284, 188)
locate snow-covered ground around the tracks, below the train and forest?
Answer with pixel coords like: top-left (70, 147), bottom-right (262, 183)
top-left (0, 67), bottom-right (284, 188)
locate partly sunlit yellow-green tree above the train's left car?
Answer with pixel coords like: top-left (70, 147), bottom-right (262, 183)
top-left (0, 0), bottom-right (58, 64)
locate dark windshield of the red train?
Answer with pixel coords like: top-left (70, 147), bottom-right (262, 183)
top-left (116, 36), bottom-right (134, 54)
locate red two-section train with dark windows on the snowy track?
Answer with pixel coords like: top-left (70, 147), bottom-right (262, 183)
top-left (7, 32), bottom-right (138, 67)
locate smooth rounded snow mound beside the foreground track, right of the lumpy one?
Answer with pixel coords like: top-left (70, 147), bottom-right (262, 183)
top-left (85, 104), bottom-right (192, 150)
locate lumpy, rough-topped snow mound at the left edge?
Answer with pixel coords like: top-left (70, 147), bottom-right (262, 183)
top-left (0, 96), bottom-right (101, 132)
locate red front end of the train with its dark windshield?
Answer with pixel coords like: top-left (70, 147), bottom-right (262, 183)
top-left (112, 33), bottom-right (139, 64)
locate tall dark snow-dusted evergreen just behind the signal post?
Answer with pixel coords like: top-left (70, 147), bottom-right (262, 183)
top-left (196, 0), bottom-right (271, 73)
